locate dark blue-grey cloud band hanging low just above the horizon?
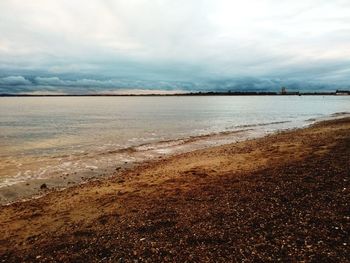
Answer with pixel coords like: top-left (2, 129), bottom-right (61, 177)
top-left (0, 76), bottom-right (350, 94)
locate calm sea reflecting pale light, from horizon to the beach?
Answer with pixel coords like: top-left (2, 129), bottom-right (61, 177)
top-left (0, 96), bottom-right (350, 201)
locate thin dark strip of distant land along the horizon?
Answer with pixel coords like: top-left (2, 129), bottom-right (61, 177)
top-left (0, 91), bottom-right (350, 97)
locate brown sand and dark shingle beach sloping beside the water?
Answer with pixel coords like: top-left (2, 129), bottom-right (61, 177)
top-left (0, 118), bottom-right (350, 262)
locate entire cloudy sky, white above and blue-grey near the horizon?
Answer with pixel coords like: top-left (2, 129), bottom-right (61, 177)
top-left (0, 0), bottom-right (350, 94)
